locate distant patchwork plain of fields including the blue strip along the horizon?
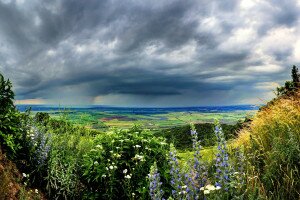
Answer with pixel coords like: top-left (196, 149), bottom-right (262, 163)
top-left (18, 105), bottom-right (258, 131)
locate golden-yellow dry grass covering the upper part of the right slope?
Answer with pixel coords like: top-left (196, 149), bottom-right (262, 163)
top-left (235, 92), bottom-right (300, 148)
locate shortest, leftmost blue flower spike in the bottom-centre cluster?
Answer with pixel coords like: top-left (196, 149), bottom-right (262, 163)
top-left (148, 162), bottom-right (164, 200)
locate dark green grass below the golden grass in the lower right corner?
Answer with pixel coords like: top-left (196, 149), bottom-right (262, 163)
top-left (251, 126), bottom-right (300, 199)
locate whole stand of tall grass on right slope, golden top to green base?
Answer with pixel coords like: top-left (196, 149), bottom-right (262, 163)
top-left (234, 92), bottom-right (300, 199)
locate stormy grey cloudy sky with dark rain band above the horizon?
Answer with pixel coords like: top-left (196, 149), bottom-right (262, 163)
top-left (0, 0), bottom-right (300, 107)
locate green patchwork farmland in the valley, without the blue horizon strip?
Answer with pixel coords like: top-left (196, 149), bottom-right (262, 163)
top-left (45, 111), bottom-right (256, 130)
